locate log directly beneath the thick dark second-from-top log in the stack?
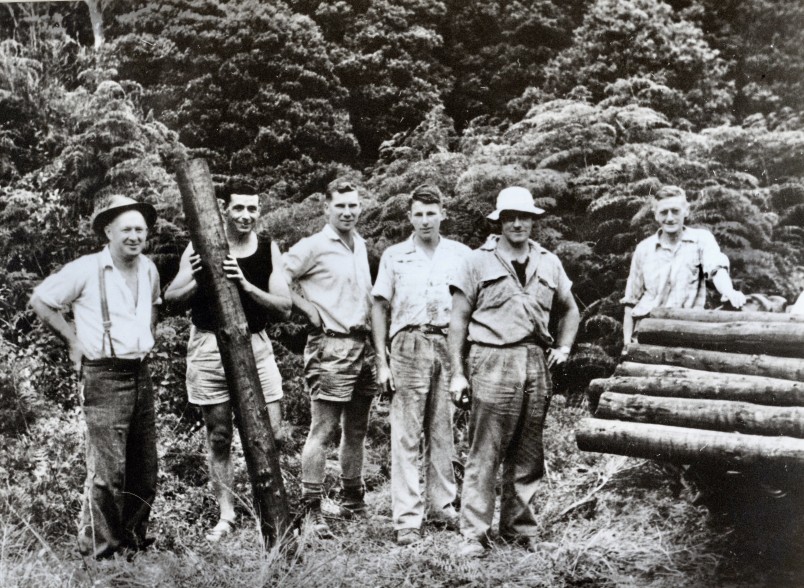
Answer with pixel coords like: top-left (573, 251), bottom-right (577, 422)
top-left (623, 343), bottom-right (804, 382)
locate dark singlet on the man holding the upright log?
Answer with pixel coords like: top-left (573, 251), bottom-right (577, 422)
top-left (190, 239), bottom-right (273, 333)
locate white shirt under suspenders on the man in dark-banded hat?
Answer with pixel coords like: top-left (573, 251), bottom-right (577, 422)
top-left (34, 246), bottom-right (162, 359)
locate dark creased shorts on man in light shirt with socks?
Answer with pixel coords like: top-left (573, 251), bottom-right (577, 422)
top-left (304, 333), bottom-right (377, 402)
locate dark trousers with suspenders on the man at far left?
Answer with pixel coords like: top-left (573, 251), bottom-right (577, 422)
top-left (78, 361), bottom-right (157, 557)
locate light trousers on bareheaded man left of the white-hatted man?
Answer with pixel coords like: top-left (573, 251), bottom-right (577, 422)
top-left (390, 331), bottom-right (456, 530)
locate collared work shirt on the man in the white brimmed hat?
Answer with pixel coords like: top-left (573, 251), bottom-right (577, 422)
top-left (450, 236), bottom-right (572, 346)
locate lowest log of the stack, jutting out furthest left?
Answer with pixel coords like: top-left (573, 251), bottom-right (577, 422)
top-left (575, 418), bottom-right (804, 471)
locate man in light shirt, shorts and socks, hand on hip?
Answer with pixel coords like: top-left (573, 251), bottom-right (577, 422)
top-left (284, 181), bottom-right (377, 537)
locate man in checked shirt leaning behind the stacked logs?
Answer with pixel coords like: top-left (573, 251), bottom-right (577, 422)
top-left (621, 186), bottom-right (745, 345)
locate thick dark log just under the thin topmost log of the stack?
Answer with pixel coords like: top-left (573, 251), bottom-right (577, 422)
top-left (637, 318), bottom-right (804, 357)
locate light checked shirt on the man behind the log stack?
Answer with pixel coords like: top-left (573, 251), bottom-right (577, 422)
top-left (620, 227), bottom-right (729, 318)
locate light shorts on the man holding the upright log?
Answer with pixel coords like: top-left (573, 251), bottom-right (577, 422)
top-left (186, 327), bottom-right (282, 404)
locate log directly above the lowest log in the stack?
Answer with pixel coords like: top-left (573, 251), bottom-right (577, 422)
top-left (595, 392), bottom-right (804, 437)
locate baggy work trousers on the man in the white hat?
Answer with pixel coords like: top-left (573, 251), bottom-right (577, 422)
top-left (461, 343), bottom-right (551, 541)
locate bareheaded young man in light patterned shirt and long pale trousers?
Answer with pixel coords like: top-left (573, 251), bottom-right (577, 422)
top-left (372, 184), bottom-right (471, 545)
